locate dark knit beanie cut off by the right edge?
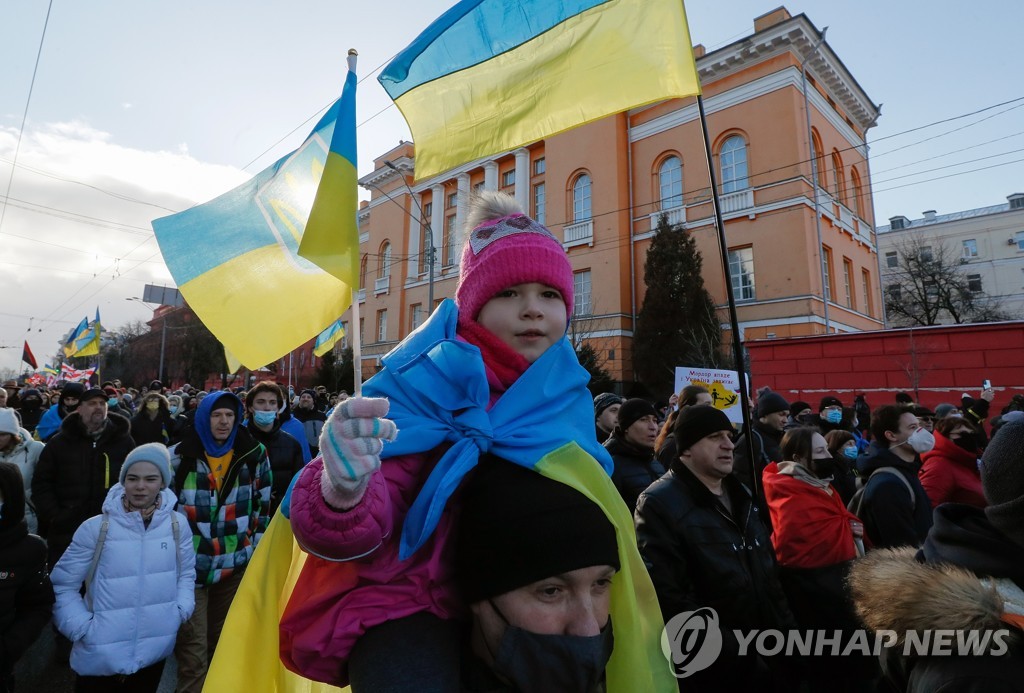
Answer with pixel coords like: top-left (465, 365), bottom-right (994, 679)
top-left (981, 421), bottom-right (1024, 547)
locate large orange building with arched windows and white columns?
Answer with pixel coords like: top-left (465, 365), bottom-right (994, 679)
top-left (344, 7), bottom-right (883, 382)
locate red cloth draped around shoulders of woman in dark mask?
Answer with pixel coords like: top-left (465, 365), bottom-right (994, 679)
top-left (762, 462), bottom-right (860, 568)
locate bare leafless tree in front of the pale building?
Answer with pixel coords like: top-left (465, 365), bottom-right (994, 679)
top-left (884, 236), bottom-right (1009, 327)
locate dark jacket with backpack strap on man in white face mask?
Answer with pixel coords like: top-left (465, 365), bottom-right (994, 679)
top-left (857, 442), bottom-right (932, 549)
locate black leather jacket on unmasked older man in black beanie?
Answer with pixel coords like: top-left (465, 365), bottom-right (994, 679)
top-left (636, 463), bottom-right (797, 690)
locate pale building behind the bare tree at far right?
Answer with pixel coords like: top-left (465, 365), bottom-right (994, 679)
top-left (878, 192), bottom-right (1024, 324)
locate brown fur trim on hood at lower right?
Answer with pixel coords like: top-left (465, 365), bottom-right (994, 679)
top-left (849, 548), bottom-right (1024, 640)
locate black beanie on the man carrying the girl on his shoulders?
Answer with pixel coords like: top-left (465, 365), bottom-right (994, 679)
top-left (456, 454), bottom-right (620, 604)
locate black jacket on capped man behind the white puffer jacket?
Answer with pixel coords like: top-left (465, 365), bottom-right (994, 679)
top-left (32, 412), bottom-right (135, 568)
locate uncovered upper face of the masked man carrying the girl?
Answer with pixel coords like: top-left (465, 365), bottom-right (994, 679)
top-left (470, 565), bottom-right (615, 652)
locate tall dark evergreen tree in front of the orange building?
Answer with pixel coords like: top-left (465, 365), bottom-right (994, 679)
top-left (633, 214), bottom-right (725, 399)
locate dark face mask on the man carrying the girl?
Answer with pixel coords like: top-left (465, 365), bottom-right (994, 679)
top-left (490, 602), bottom-right (614, 693)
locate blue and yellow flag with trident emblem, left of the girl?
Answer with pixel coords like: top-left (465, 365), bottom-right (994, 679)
top-left (153, 62), bottom-right (358, 370)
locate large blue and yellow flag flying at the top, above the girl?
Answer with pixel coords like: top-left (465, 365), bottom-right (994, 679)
top-left (378, 0), bottom-right (700, 180)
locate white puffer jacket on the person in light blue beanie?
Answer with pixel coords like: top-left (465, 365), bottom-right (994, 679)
top-left (50, 483), bottom-right (196, 676)
